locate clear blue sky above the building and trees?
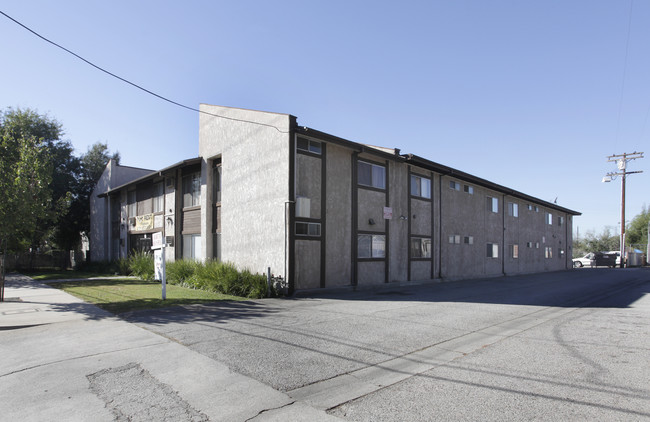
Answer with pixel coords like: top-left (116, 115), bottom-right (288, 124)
top-left (0, 0), bottom-right (650, 235)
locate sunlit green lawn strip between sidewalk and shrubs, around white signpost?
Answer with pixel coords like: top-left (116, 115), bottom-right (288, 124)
top-left (50, 279), bottom-right (248, 314)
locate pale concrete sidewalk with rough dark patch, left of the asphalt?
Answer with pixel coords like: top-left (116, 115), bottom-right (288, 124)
top-left (0, 274), bottom-right (338, 421)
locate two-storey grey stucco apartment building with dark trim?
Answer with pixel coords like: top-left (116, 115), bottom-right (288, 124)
top-left (91, 104), bottom-right (580, 291)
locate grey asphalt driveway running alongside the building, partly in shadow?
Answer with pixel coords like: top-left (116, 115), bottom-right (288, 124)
top-left (127, 268), bottom-right (650, 421)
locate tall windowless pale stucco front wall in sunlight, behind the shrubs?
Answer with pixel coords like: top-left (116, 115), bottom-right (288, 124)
top-left (199, 104), bottom-right (291, 275)
